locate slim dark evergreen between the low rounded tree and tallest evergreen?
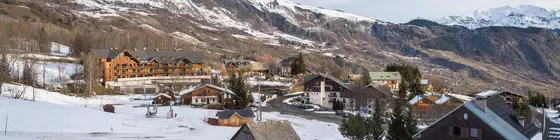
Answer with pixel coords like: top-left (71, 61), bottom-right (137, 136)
top-left (366, 99), bottom-right (383, 140)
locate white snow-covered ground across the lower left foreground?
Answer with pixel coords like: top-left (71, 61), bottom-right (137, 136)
top-left (0, 84), bottom-right (344, 140)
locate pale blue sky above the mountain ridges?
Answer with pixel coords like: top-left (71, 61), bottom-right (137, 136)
top-left (295, 0), bottom-right (560, 23)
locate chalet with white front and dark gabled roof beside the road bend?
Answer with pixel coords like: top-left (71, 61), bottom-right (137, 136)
top-left (304, 74), bottom-right (353, 108)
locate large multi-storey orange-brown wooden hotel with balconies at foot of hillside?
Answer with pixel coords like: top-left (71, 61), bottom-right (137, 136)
top-left (90, 48), bottom-right (211, 93)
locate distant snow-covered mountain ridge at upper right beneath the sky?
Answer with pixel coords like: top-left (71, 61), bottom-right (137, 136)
top-left (435, 5), bottom-right (560, 29)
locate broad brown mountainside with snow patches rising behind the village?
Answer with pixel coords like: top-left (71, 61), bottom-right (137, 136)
top-left (0, 0), bottom-right (560, 93)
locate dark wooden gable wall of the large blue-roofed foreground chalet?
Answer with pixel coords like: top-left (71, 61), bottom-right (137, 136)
top-left (419, 107), bottom-right (505, 140)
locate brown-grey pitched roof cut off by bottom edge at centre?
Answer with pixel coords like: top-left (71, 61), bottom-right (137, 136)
top-left (234, 120), bottom-right (300, 140)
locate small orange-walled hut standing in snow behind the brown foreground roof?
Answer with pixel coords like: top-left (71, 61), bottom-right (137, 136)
top-left (216, 108), bottom-right (255, 126)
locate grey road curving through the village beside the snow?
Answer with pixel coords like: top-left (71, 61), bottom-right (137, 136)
top-left (263, 95), bottom-right (343, 125)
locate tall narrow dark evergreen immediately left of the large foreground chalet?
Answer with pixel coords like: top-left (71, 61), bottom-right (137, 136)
top-left (387, 84), bottom-right (412, 140)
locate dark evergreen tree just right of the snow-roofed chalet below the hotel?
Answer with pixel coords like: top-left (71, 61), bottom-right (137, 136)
top-left (228, 73), bottom-right (250, 108)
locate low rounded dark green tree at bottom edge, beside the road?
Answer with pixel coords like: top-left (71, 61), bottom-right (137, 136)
top-left (338, 115), bottom-right (368, 140)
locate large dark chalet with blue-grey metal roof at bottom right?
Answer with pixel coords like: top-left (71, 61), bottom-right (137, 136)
top-left (413, 92), bottom-right (540, 140)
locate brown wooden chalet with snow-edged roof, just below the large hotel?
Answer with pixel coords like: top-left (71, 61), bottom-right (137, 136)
top-left (179, 83), bottom-right (235, 105)
